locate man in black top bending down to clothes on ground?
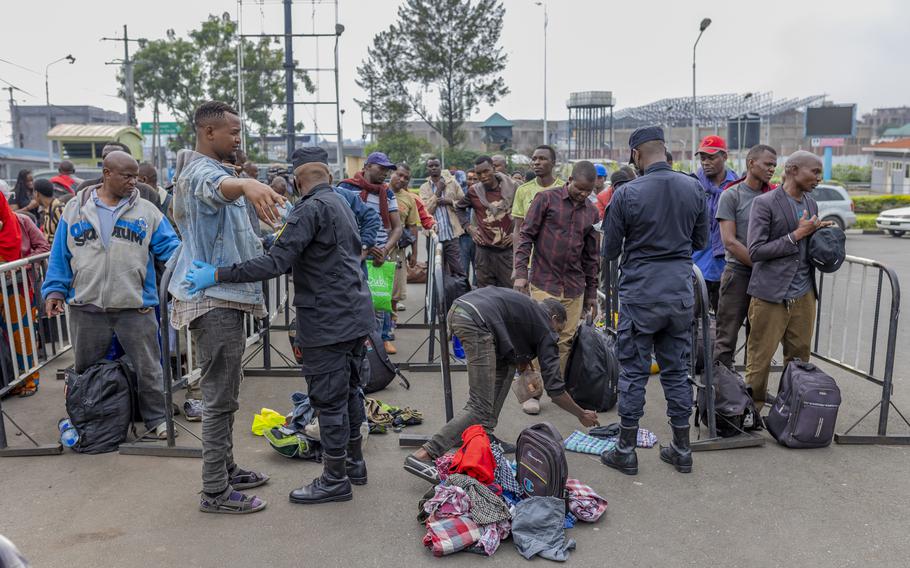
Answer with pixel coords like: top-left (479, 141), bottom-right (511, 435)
top-left (404, 286), bottom-right (598, 483)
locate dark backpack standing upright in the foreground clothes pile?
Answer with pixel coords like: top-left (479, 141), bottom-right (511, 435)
top-left (515, 422), bottom-right (569, 499)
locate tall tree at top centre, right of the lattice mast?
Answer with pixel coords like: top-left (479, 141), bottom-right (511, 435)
top-left (357, 0), bottom-right (509, 147)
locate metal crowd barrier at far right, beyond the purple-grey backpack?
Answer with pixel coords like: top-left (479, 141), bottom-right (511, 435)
top-left (812, 256), bottom-right (910, 445)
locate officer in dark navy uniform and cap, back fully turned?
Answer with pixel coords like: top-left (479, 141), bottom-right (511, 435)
top-left (601, 126), bottom-right (708, 475)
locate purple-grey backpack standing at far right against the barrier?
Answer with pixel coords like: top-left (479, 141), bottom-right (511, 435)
top-left (765, 359), bottom-right (841, 448)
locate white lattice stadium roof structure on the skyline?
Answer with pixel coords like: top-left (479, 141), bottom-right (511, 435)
top-left (614, 92), bottom-right (825, 124)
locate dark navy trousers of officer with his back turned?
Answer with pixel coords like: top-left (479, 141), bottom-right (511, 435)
top-left (616, 300), bottom-right (693, 428)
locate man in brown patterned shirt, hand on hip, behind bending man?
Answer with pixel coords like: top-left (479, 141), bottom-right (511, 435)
top-left (455, 156), bottom-right (515, 288)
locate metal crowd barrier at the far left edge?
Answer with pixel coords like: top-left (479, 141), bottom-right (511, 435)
top-left (0, 253), bottom-right (70, 457)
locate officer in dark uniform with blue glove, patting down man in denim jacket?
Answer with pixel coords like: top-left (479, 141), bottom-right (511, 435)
top-left (187, 147), bottom-right (376, 504)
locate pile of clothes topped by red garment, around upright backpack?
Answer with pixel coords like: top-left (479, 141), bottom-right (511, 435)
top-left (417, 425), bottom-right (607, 561)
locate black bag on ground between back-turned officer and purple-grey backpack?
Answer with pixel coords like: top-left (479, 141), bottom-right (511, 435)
top-left (695, 361), bottom-right (761, 438)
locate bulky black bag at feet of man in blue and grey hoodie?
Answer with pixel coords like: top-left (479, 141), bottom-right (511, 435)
top-left (66, 359), bottom-right (134, 454)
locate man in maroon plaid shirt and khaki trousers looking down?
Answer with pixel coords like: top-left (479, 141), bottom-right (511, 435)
top-left (514, 161), bottom-right (598, 382)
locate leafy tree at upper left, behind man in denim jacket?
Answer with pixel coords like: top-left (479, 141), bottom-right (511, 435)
top-left (119, 15), bottom-right (313, 155)
